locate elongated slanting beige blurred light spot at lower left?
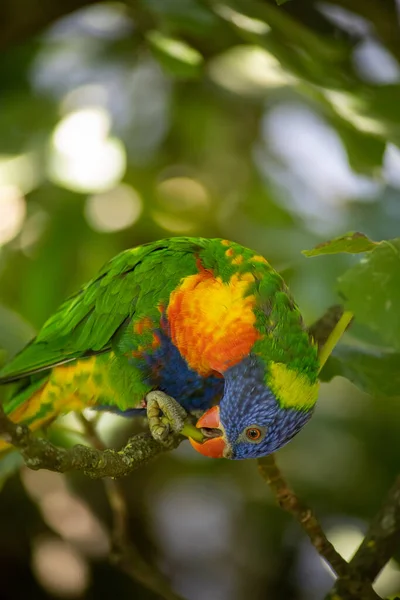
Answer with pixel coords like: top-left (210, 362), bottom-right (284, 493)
top-left (22, 469), bottom-right (110, 557)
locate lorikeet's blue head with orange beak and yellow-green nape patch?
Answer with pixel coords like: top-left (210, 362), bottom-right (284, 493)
top-left (190, 355), bottom-right (318, 459)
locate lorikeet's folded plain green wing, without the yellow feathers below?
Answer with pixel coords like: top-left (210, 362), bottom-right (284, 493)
top-left (0, 238), bottom-right (203, 383)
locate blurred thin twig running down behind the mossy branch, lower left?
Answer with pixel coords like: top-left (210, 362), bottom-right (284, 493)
top-left (79, 414), bottom-right (183, 600)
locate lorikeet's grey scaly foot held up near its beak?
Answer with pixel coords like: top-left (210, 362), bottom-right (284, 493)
top-left (146, 390), bottom-right (188, 446)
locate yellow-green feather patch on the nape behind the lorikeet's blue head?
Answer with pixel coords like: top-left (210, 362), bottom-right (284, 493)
top-left (268, 362), bottom-right (319, 410)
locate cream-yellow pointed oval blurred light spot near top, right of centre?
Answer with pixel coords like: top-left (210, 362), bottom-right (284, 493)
top-left (208, 46), bottom-right (296, 96)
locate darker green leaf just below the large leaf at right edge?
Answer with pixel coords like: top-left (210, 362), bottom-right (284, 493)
top-left (320, 346), bottom-right (400, 398)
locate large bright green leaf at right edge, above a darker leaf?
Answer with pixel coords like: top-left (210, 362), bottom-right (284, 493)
top-left (338, 238), bottom-right (400, 352)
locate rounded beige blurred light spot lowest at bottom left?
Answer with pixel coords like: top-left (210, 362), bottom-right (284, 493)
top-left (32, 537), bottom-right (89, 598)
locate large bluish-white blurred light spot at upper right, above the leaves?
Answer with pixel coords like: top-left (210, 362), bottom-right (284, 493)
top-left (256, 104), bottom-right (379, 233)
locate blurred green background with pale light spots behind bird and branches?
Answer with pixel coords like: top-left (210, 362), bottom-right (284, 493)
top-left (0, 0), bottom-right (400, 600)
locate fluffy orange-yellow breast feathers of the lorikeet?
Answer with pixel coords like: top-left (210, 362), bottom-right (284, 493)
top-left (167, 268), bottom-right (259, 377)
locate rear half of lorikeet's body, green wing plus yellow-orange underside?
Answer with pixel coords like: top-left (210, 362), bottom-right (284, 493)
top-left (0, 238), bottom-right (208, 451)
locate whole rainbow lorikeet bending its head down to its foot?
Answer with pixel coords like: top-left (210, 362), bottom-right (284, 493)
top-left (0, 237), bottom-right (319, 459)
